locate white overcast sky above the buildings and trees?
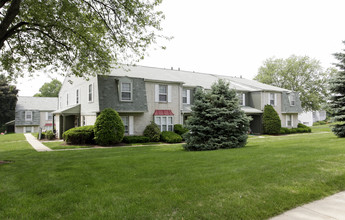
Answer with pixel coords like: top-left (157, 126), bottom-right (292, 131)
top-left (17, 0), bottom-right (345, 96)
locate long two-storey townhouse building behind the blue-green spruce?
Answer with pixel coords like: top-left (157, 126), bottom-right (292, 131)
top-left (54, 66), bottom-right (302, 138)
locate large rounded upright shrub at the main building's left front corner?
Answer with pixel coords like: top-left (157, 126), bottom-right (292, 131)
top-left (94, 108), bottom-right (125, 145)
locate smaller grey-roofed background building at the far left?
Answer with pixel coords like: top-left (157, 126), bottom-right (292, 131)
top-left (14, 96), bottom-right (58, 133)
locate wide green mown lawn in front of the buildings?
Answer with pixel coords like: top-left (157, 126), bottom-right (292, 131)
top-left (0, 126), bottom-right (345, 219)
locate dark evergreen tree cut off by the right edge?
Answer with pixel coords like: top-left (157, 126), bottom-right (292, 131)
top-left (330, 41), bottom-right (345, 137)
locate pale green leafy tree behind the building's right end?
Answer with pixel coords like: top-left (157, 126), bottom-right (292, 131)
top-left (254, 55), bottom-right (336, 111)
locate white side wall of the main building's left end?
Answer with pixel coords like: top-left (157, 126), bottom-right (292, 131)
top-left (58, 76), bottom-right (99, 115)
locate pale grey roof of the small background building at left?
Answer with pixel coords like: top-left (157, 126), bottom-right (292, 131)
top-left (16, 96), bottom-right (58, 111)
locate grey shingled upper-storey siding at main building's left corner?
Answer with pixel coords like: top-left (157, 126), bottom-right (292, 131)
top-left (98, 76), bottom-right (147, 112)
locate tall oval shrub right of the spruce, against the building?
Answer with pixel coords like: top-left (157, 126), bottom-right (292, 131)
top-left (262, 105), bottom-right (281, 134)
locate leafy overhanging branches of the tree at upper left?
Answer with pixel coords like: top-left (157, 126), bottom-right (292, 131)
top-left (0, 0), bottom-right (164, 78)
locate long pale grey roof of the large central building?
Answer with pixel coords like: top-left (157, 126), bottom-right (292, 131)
top-left (106, 66), bottom-right (290, 92)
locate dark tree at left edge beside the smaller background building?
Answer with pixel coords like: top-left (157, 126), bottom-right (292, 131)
top-left (0, 74), bottom-right (18, 130)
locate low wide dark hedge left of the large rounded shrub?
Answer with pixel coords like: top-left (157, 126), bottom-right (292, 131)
top-left (62, 125), bottom-right (94, 144)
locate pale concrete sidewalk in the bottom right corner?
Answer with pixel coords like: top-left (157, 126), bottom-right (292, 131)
top-left (271, 192), bottom-right (345, 220)
